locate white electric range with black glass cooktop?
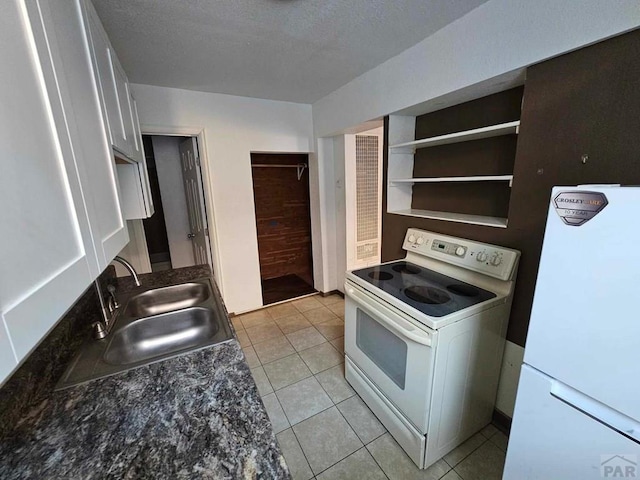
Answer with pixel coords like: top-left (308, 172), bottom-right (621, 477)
top-left (345, 228), bottom-right (520, 468)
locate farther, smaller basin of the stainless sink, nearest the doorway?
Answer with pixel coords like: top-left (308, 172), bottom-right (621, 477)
top-left (124, 282), bottom-right (211, 317)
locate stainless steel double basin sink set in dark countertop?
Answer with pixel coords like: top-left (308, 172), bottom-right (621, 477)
top-left (56, 278), bottom-right (233, 389)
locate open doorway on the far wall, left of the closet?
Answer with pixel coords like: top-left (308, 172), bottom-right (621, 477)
top-left (142, 135), bottom-right (211, 272)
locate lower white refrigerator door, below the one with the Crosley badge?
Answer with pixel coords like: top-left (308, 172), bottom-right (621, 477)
top-left (503, 365), bottom-right (640, 480)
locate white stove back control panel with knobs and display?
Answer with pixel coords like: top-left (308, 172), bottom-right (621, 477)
top-left (402, 228), bottom-right (520, 280)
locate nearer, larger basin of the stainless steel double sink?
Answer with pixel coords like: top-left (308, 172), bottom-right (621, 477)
top-left (104, 307), bottom-right (220, 365)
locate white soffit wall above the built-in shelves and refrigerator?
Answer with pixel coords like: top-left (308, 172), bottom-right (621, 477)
top-left (313, 0), bottom-right (640, 137)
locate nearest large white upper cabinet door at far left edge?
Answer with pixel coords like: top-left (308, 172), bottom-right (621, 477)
top-left (0, 2), bottom-right (99, 368)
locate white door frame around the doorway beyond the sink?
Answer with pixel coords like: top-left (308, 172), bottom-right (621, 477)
top-left (140, 124), bottom-right (224, 296)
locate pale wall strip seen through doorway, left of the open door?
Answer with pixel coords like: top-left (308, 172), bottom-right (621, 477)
top-left (151, 135), bottom-right (195, 268)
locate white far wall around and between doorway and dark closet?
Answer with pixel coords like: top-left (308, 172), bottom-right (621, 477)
top-left (133, 85), bottom-right (314, 313)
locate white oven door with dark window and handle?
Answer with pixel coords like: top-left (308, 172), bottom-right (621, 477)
top-left (344, 282), bottom-right (437, 433)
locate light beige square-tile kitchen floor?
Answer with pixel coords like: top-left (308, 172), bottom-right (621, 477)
top-left (232, 295), bottom-right (507, 480)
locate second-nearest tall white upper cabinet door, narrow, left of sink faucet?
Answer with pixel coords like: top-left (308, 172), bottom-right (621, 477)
top-left (33, 0), bottom-right (129, 271)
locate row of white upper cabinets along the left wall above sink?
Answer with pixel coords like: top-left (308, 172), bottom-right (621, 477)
top-left (0, 0), bottom-right (153, 384)
